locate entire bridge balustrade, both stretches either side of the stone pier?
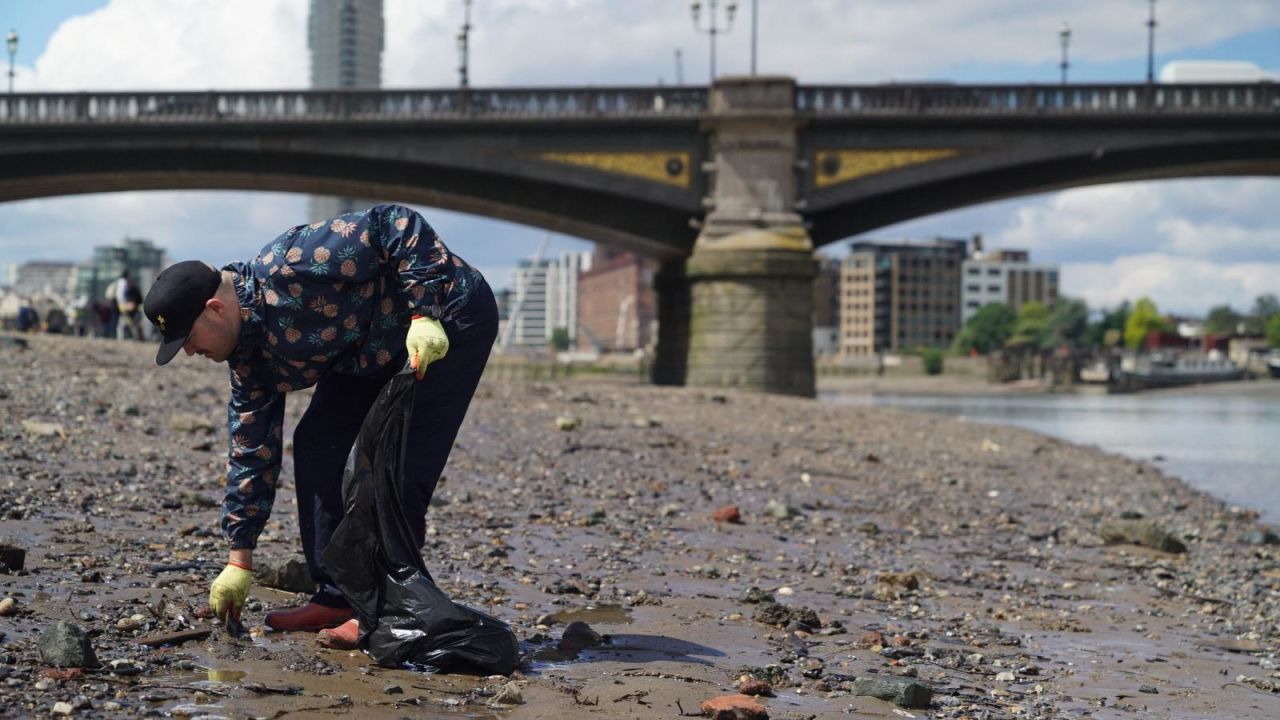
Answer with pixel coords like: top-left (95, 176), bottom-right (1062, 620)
top-left (0, 82), bottom-right (1280, 124)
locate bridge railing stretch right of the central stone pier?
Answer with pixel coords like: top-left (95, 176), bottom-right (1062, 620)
top-left (796, 82), bottom-right (1280, 115)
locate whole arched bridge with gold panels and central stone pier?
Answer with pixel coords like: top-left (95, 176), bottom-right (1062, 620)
top-left (0, 77), bottom-right (1280, 395)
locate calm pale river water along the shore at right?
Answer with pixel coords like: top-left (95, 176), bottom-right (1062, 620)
top-left (820, 383), bottom-right (1280, 523)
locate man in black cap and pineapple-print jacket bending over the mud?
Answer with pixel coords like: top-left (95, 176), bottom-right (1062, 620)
top-left (143, 205), bottom-right (498, 647)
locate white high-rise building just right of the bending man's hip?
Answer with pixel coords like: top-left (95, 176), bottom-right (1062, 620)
top-left (502, 252), bottom-right (591, 347)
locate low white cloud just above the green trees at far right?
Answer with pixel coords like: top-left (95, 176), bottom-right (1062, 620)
top-left (1061, 254), bottom-right (1280, 314)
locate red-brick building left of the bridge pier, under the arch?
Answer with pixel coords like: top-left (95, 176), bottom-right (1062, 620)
top-left (576, 245), bottom-right (658, 352)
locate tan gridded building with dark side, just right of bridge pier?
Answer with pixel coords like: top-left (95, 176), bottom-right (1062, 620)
top-left (840, 238), bottom-right (968, 356)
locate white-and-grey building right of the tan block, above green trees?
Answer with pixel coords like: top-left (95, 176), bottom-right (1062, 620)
top-left (960, 245), bottom-right (1057, 323)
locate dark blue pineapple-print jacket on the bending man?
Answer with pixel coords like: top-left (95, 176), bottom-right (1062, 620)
top-left (221, 205), bottom-right (483, 548)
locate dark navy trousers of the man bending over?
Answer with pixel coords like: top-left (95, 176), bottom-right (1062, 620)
top-left (293, 283), bottom-right (498, 607)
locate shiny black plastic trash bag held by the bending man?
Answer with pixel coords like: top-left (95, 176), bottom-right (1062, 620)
top-left (321, 372), bottom-right (518, 675)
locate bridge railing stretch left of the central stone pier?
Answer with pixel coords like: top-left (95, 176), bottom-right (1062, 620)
top-left (0, 87), bottom-right (707, 124)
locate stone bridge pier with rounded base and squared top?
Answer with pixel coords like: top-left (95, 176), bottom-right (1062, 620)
top-left (655, 77), bottom-right (815, 397)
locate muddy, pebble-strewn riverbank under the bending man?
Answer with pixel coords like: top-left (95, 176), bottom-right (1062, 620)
top-left (0, 336), bottom-right (1280, 720)
